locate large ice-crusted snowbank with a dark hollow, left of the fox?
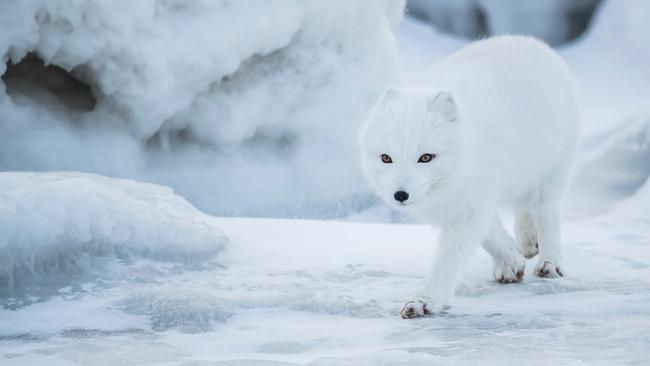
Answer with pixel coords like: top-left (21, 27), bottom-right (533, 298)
top-left (0, 0), bottom-right (404, 216)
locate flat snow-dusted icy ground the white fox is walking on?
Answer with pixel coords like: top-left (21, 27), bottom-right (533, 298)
top-left (0, 216), bottom-right (650, 365)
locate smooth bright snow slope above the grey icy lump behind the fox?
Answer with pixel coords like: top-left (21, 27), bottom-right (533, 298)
top-left (560, 0), bottom-right (650, 141)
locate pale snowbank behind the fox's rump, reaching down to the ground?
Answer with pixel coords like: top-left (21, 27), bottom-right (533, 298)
top-left (560, 0), bottom-right (650, 217)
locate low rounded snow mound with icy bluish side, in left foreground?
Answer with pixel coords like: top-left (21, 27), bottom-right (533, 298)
top-left (0, 173), bottom-right (226, 302)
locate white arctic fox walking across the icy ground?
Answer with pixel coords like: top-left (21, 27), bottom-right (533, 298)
top-left (360, 36), bottom-right (578, 318)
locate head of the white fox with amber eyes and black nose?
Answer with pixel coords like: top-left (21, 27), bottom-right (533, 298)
top-left (360, 89), bottom-right (462, 209)
